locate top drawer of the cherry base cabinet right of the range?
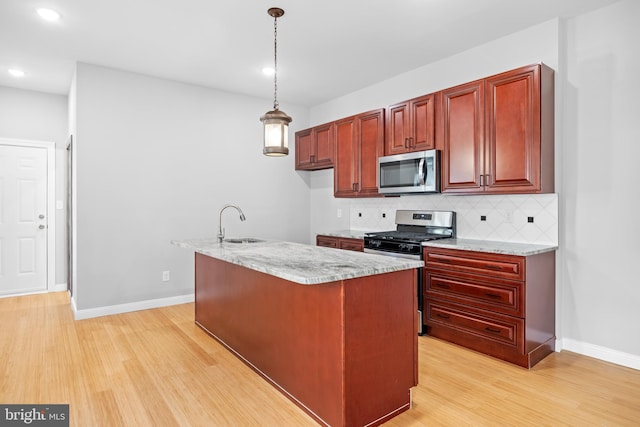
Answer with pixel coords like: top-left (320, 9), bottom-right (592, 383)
top-left (424, 248), bottom-right (525, 280)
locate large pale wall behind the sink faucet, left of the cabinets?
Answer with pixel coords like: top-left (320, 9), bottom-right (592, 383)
top-left (71, 64), bottom-right (309, 311)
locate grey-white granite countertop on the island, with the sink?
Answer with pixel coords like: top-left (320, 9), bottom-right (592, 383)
top-left (171, 238), bottom-right (424, 285)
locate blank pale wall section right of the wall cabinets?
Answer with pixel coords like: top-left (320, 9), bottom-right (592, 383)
top-left (560, 0), bottom-right (640, 362)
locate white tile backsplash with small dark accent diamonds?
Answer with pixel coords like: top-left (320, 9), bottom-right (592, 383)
top-left (349, 194), bottom-right (558, 245)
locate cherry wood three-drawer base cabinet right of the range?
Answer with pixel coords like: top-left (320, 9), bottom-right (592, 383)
top-left (423, 247), bottom-right (556, 368)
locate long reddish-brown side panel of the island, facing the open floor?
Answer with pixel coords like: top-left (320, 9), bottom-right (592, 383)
top-left (195, 253), bottom-right (344, 426)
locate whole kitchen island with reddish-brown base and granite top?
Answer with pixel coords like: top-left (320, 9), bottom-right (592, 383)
top-left (172, 239), bottom-right (422, 426)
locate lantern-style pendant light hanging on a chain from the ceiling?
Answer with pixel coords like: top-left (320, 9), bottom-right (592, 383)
top-left (260, 7), bottom-right (292, 156)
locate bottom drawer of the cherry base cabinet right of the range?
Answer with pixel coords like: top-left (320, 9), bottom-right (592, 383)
top-left (425, 301), bottom-right (524, 351)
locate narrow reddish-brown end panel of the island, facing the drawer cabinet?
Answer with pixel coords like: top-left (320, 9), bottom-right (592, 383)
top-left (344, 270), bottom-right (418, 426)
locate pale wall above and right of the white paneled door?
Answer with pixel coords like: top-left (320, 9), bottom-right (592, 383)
top-left (0, 86), bottom-right (68, 288)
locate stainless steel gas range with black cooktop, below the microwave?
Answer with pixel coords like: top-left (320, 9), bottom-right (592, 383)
top-left (364, 210), bottom-right (456, 335)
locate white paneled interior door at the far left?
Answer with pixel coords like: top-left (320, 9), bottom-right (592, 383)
top-left (0, 145), bottom-right (48, 295)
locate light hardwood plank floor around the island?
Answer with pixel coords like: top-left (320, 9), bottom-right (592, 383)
top-left (0, 293), bottom-right (640, 427)
